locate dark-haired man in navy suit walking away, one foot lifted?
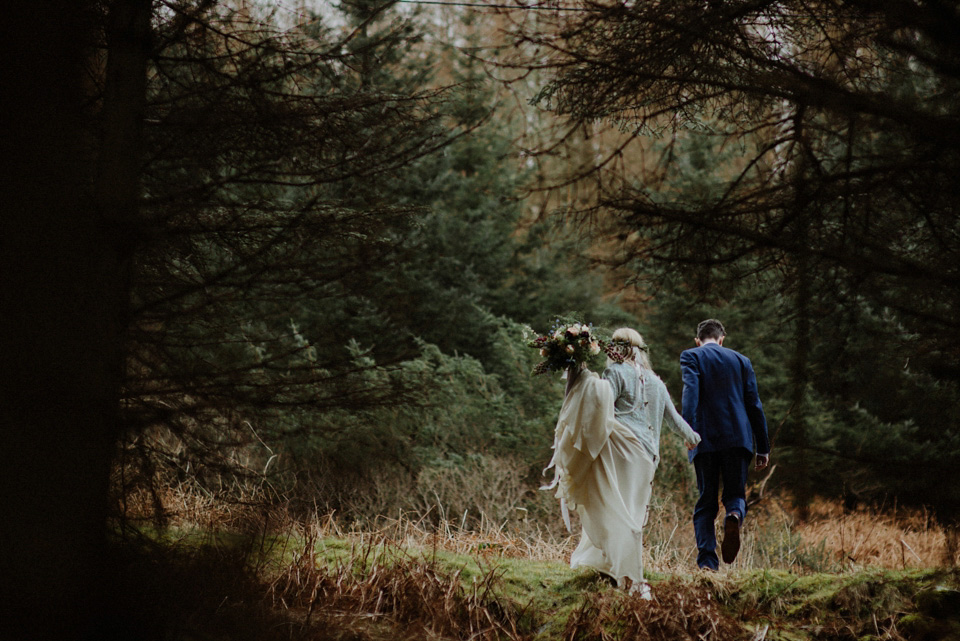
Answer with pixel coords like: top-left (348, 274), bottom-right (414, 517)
top-left (680, 318), bottom-right (770, 570)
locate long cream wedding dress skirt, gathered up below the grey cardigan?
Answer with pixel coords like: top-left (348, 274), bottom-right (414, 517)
top-left (542, 370), bottom-right (656, 585)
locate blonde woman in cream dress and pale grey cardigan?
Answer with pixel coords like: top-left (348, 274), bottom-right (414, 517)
top-left (541, 326), bottom-right (700, 599)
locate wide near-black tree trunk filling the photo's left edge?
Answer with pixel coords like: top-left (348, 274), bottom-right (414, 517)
top-left (0, 0), bottom-right (149, 640)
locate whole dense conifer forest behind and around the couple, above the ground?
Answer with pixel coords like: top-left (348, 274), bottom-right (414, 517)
top-left (0, 0), bottom-right (960, 638)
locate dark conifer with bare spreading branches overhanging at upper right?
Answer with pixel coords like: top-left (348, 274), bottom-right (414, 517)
top-left (512, 0), bottom-right (960, 517)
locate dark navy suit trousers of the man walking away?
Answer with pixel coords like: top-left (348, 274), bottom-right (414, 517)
top-left (693, 447), bottom-right (753, 570)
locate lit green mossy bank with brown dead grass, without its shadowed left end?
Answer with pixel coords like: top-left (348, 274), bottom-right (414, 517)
top-left (274, 540), bottom-right (960, 641)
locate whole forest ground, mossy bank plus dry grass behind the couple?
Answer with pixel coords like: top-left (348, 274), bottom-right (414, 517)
top-left (115, 482), bottom-right (960, 641)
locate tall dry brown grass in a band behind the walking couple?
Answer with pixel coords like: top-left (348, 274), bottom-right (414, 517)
top-left (124, 460), bottom-right (960, 575)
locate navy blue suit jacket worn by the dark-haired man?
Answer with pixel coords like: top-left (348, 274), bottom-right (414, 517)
top-left (680, 343), bottom-right (770, 461)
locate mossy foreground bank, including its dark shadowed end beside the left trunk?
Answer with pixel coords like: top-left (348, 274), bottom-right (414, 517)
top-left (118, 516), bottom-right (960, 641)
